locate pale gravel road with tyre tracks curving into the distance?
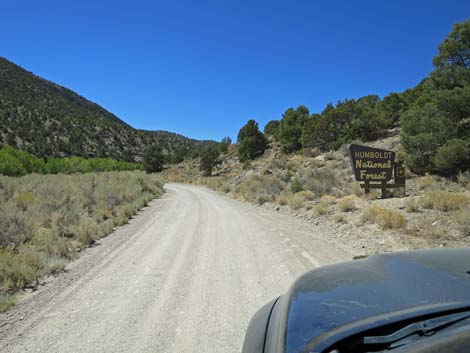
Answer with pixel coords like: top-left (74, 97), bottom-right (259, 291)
top-left (0, 184), bottom-right (350, 353)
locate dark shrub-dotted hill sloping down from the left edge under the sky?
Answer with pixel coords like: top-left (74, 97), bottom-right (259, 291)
top-left (0, 57), bottom-right (209, 161)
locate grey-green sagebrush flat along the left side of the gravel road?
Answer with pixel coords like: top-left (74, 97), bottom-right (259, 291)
top-left (0, 171), bottom-right (163, 311)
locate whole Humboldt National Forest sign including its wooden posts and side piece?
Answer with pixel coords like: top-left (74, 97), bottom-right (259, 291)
top-left (349, 145), bottom-right (406, 198)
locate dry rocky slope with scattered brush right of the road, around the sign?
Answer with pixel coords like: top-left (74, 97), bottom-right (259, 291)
top-left (163, 130), bottom-right (470, 255)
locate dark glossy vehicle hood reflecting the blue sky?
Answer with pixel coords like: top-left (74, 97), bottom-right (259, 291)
top-left (281, 249), bottom-right (470, 353)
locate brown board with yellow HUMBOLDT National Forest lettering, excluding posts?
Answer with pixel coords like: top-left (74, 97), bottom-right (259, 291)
top-left (349, 145), bottom-right (395, 183)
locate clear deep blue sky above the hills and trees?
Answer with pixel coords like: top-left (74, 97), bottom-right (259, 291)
top-left (0, 0), bottom-right (470, 140)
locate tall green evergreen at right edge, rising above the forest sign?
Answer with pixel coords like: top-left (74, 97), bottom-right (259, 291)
top-left (401, 20), bottom-right (470, 176)
